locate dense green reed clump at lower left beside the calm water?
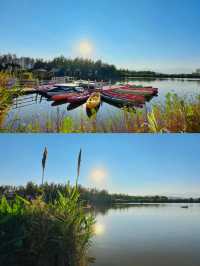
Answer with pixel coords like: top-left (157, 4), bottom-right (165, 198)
top-left (0, 149), bottom-right (95, 266)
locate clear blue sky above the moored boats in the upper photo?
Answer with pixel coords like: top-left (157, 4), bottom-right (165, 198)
top-left (0, 0), bottom-right (200, 72)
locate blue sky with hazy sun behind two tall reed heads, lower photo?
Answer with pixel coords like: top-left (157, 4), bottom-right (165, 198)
top-left (0, 134), bottom-right (200, 196)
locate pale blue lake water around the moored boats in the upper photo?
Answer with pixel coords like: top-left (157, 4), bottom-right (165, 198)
top-left (5, 80), bottom-right (200, 125)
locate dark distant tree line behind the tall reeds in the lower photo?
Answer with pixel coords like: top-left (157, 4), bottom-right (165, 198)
top-left (0, 182), bottom-right (200, 206)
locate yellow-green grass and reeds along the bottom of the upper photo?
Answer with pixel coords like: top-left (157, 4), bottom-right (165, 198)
top-left (0, 94), bottom-right (200, 133)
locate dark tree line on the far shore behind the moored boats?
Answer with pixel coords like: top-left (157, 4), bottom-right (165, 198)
top-left (0, 54), bottom-right (200, 80)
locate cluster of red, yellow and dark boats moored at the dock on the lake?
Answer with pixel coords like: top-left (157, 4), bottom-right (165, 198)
top-left (37, 83), bottom-right (158, 109)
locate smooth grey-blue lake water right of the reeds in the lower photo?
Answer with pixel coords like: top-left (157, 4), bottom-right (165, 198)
top-left (90, 204), bottom-right (200, 266)
